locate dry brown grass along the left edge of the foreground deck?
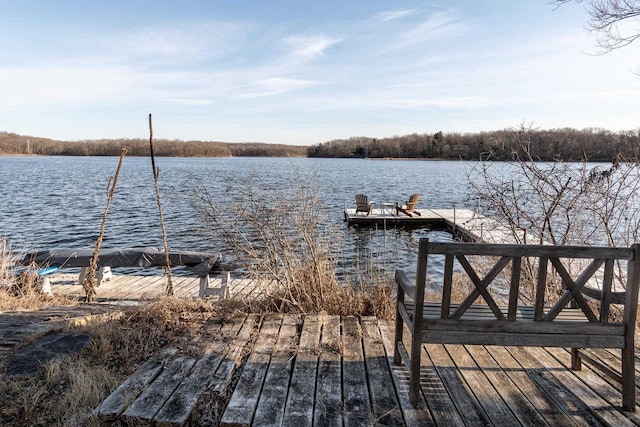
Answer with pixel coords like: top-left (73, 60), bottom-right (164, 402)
top-left (0, 298), bottom-right (230, 426)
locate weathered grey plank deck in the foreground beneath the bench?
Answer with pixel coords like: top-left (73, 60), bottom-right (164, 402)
top-left (96, 315), bottom-right (640, 427)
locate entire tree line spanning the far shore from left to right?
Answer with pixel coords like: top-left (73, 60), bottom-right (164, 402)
top-left (5, 127), bottom-right (640, 161)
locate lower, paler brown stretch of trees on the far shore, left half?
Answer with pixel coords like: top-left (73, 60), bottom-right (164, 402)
top-left (0, 132), bottom-right (307, 157)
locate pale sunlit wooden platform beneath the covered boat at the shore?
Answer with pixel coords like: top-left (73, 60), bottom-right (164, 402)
top-left (47, 273), bottom-right (260, 302)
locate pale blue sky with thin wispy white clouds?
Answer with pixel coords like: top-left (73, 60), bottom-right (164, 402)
top-left (0, 0), bottom-right (640, 145)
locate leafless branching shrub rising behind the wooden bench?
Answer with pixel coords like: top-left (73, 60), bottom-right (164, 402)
top-left (469, 125), bottom-right (640, 295)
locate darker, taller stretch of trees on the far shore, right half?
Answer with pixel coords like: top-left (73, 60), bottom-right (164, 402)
top-left (307, 128), bottom-right (640, 161)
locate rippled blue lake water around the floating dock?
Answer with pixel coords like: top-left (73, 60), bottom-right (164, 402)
top-left (0, 157), bottom-right (482, 273)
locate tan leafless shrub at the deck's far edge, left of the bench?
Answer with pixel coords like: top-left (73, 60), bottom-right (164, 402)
top-left (199, 170), bottom-right (391, 315)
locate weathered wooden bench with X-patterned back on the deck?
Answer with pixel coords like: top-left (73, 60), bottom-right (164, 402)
top-left (394, 239), bottom-right (640, 411)
